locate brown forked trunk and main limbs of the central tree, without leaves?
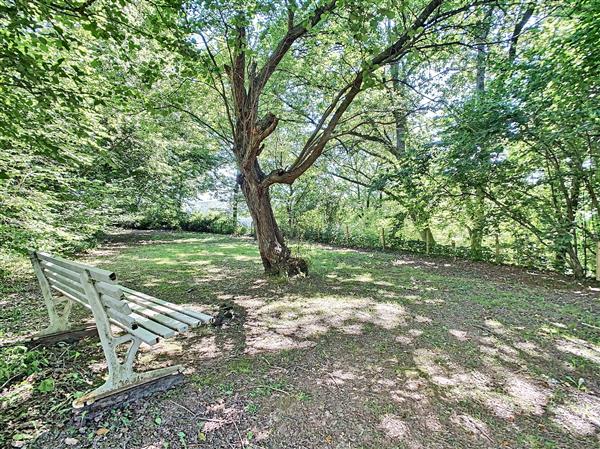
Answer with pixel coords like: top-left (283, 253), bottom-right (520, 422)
top-left (223, 0), bottom-right (443, 275)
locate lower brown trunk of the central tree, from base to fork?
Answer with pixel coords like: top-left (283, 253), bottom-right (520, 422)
top-left (240, 163), bottom-right (308, 276)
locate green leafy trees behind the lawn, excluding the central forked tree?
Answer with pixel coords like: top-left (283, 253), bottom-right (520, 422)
top-left (0, 1), bottom-right (600, 277)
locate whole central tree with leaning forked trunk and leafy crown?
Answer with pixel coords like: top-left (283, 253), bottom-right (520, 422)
top-left (173, 0), bottom-right (496, 274)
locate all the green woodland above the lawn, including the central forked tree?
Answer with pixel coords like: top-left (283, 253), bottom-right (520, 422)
top-left (0, 0), bottom-right (600, 277)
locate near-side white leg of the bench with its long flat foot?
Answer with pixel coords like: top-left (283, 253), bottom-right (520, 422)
top-left (73, 335), bottom-right (183, 408)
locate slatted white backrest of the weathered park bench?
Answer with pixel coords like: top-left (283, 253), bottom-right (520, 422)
top-left (31, 251), bottom-right (137, 329)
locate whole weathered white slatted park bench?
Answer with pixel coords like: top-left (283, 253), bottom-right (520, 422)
top-left (30, 251), bottom-right (212, 408)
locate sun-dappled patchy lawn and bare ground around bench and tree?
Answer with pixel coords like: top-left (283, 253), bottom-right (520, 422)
top-left (0, 232), bottom-right (600, 449)
